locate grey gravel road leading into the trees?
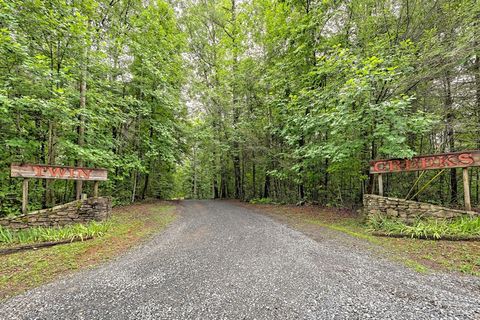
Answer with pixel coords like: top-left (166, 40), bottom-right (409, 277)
top-left (0, 201), bottom-right (480, 320)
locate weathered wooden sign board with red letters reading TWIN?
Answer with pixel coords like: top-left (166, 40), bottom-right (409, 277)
top-left (10, 164), bottom-right (108, 181)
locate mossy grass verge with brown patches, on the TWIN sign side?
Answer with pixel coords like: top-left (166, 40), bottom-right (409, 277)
top-left (0, 202), bottom-right (175, 300)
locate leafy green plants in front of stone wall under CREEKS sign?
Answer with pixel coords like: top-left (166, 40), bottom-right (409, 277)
top-left (368, 216), bottom-right (480, 239)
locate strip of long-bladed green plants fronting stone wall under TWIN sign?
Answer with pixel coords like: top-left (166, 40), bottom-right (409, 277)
top-left (0, 221), bottom-right (111, 245)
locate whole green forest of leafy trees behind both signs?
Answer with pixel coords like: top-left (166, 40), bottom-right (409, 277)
top-left (0, 0), bottom-right (480, 216)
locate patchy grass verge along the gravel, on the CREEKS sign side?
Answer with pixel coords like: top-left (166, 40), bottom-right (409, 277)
top-left (246, 204), bottom-right (480, 276)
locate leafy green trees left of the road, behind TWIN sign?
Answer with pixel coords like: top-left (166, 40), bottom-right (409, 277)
top-left (0, 0), bottom-right (185, 212)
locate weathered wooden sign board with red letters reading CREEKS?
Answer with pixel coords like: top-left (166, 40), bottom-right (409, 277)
top-left (370, 150), bottom-right (480, 174)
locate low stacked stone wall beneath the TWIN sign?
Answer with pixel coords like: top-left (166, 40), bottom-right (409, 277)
top-left (0, 197), bottom-right (112, 230)
